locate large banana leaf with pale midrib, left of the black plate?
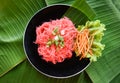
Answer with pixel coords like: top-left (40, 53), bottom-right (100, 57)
top-left (0, 0), bottom-right (46, 77)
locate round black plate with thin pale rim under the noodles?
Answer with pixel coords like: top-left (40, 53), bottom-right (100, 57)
top-left (24, 5), bottom-right (90, 78)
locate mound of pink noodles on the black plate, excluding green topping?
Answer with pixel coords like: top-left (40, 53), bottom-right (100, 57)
top-left (35, 17), bottom-right (77, 64)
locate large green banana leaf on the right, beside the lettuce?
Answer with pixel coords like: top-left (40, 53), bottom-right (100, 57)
top-left (86, 0), bottom-right (120, 83)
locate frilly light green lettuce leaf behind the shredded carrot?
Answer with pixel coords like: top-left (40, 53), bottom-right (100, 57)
top-left (77, 20), bottom-right (106, 61)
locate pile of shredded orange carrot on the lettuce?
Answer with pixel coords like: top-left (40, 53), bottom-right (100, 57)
top-left (73, 29), bottom-right (94, 60)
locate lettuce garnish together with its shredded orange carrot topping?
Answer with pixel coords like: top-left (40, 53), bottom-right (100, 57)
top-left (74, 20), bottom-right (106, 61)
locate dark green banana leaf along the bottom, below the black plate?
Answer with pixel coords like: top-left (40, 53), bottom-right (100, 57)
top-left (0, 60), bottom-right (91, 83)
